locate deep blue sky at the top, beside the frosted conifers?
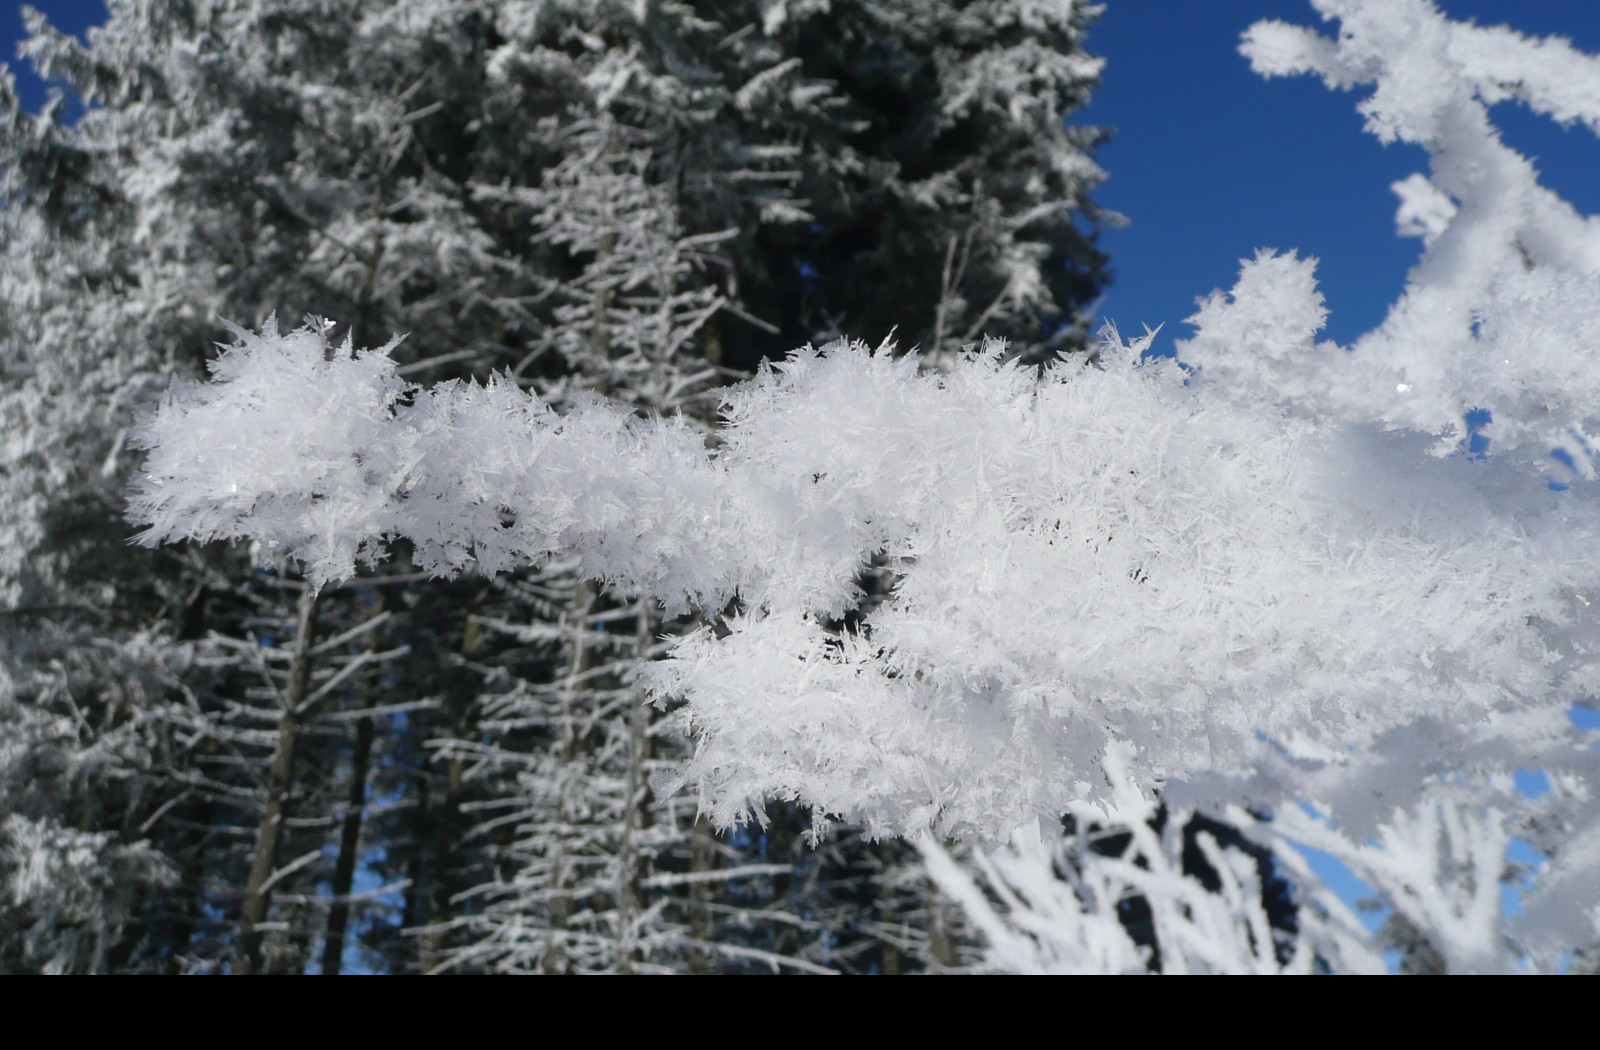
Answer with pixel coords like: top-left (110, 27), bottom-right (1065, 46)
top-left (9, 0), bottom-right (1600, 346)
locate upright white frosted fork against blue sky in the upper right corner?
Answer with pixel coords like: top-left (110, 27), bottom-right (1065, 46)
top-left (1203, 0), bottom-right (1600, 477)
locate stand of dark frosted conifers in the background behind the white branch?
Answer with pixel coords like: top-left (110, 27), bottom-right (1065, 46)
top-left (0, 0), bottom-right (1104, 972)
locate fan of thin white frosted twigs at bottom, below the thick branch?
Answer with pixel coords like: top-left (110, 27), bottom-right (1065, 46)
top-left (918, 747), bottom-right (1384, 973)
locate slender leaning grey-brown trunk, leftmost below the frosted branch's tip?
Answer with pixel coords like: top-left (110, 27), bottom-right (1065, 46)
top-left (238, 586), bottom-right (317, 973)
